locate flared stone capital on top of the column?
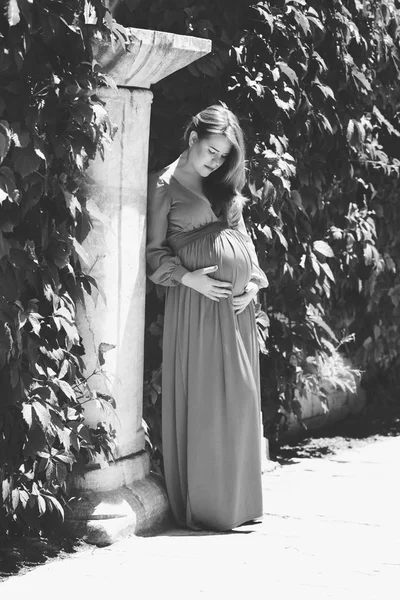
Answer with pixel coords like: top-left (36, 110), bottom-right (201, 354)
top-left (92, 23), bottom-right (212, 88)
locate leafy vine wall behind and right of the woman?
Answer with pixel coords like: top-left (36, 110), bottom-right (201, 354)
top-left (117, 0), bottom-right (400, 460)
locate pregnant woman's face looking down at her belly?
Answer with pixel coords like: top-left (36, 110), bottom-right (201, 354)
top-left (188, 131), bottom-right (232, 177)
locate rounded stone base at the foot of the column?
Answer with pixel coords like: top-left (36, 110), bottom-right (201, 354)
top-left (64, 474), bottom-right (171, 546)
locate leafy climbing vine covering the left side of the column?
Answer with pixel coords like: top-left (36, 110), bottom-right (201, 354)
top-left (0, 0), bottom-right (115, 532)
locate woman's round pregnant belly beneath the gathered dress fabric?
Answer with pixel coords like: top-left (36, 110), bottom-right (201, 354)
top-left (177, 229), bottom-right (251, 296)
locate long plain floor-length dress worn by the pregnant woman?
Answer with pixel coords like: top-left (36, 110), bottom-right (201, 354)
top-left (147, 166), bottom-right (268, 531)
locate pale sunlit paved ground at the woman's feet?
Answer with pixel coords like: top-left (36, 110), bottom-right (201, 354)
top-left (0, 437), bottom-right (400, 600)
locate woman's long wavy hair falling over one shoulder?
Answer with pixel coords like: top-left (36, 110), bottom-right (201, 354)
top-left (183, 104), bottom-right (245, 220)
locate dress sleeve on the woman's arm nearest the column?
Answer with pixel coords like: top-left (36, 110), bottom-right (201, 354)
top-left (146, 178), bottom-right (188, 287)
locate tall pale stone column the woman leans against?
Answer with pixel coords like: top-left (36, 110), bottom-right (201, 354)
top-left (66, 26), bottom-right (211, 544)
